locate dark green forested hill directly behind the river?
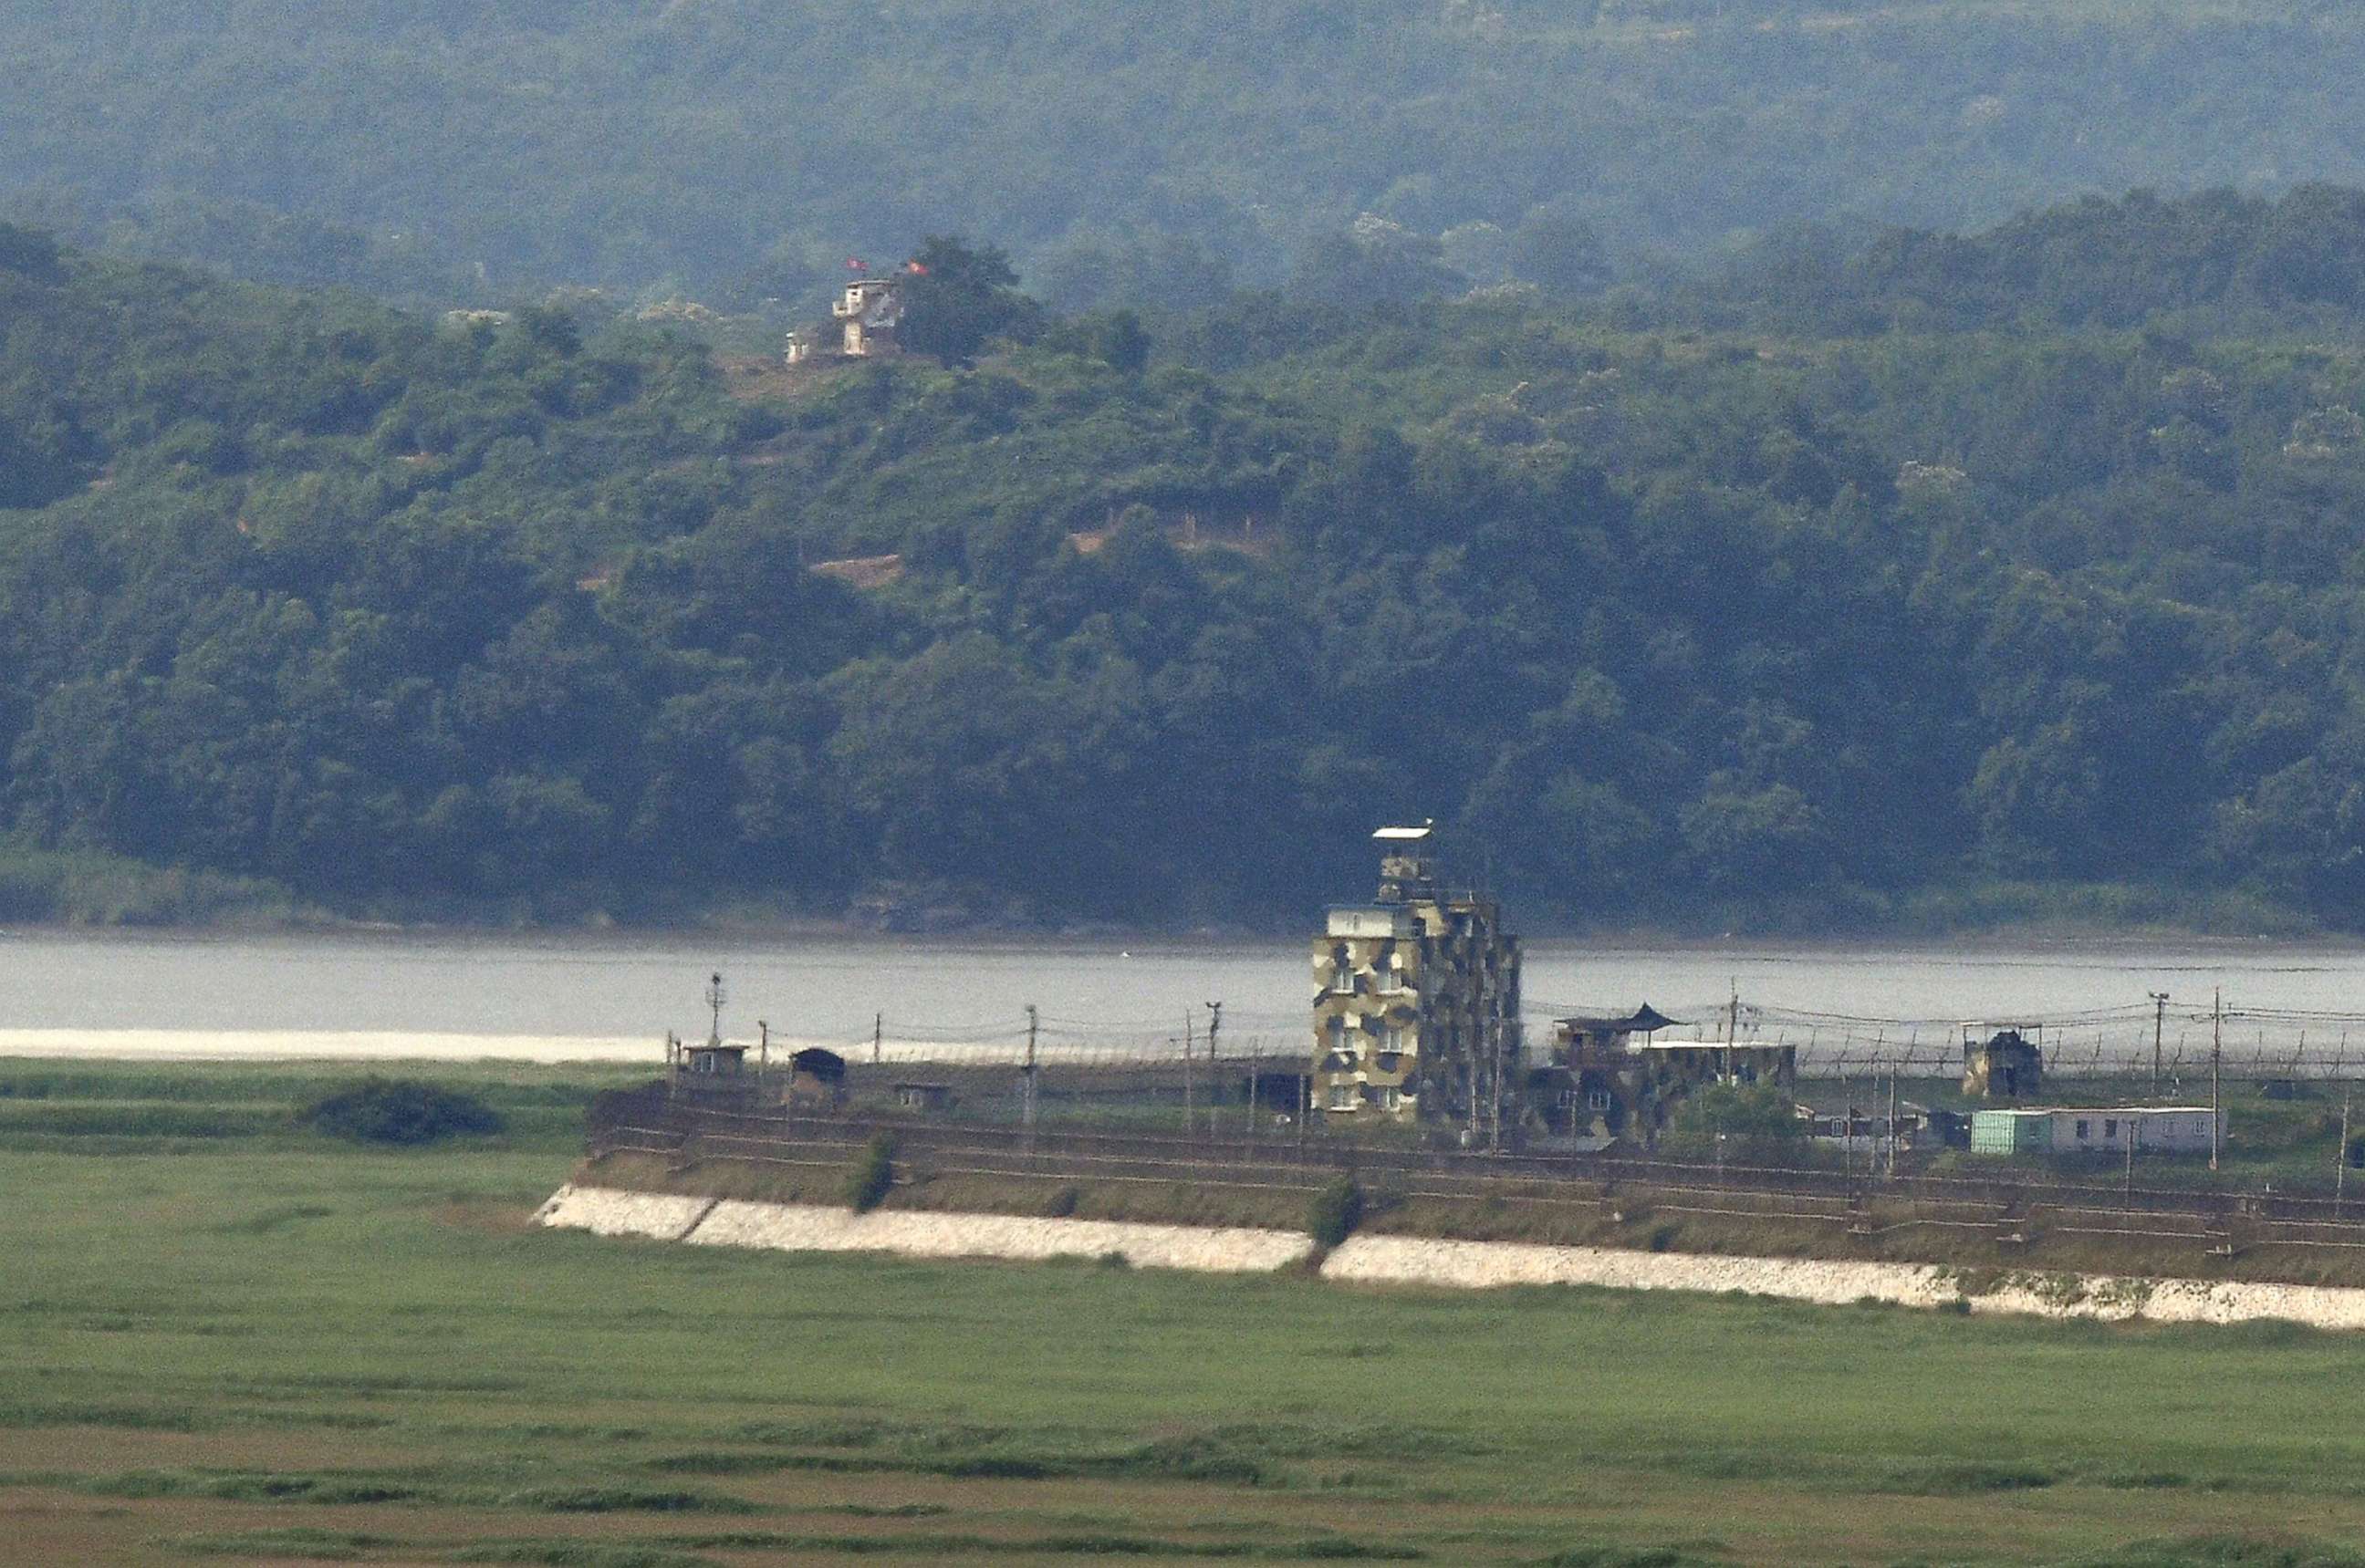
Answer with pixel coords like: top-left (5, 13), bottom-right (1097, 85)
top-left (0, 192), bottom-right (2365, 929)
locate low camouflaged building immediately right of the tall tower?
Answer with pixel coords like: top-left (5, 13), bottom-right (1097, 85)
top-left (1527, 1002), bottom-right (1797, 1147)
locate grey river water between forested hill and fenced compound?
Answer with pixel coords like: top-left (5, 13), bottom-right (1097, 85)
top-left (0, 932), bottom-right (2365, 1060)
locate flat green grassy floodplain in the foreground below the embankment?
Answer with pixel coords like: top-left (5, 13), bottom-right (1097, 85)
top-left (0, 1062), bottom-right (2365, 1565)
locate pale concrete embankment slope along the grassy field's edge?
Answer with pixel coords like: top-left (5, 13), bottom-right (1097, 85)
top-left (535, 1185), bottom-right (2365, 1329)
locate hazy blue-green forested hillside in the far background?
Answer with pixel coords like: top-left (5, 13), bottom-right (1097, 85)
top-left (14, 0), bottom-right (2365, 305)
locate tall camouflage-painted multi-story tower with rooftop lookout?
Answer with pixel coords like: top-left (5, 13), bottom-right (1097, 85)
top-left (1313, 823), bottom-right (1521, 1133)
